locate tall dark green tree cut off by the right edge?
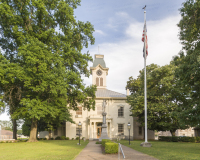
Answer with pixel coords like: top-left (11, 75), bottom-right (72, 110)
top-left (174, 0), bottom-right (200, 127)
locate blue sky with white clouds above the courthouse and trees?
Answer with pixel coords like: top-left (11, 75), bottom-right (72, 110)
top-left (0, 0), bottom-right (185, 120)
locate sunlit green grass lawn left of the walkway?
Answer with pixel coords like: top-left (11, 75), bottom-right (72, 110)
top-left (0, 140), bottom-right (89, 160)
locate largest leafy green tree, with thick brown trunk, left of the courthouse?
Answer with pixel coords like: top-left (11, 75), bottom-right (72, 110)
top-left (0, 0), bottom-right (96, 142)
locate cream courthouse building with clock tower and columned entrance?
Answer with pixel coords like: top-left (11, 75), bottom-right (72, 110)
top-left (40, 55), bottom-right (154, 140)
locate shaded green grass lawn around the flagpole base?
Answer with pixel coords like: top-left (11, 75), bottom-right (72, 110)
top-left (120, 140), bottom-right (200, 160)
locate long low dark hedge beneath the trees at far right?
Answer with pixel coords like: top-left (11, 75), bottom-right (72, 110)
top-left (159, 136), bottom-right (200, 142)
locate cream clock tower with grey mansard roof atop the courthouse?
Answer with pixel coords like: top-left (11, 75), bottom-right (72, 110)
top-left (90, 54), bottom-right (109, 88)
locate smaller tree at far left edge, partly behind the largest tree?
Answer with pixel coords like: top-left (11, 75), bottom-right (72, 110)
top-left (0, 54), bottom-right (25, 139)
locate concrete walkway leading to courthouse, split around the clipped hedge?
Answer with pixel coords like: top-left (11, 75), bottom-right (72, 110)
top-left (75, 141), bottom-right (158, 160)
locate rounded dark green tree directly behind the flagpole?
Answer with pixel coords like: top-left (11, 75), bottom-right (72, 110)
top-left (126, 64), bottom-right (187, 136)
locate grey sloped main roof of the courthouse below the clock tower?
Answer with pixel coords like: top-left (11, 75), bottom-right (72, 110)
top-left (96, 88), bottom-right (126, 98)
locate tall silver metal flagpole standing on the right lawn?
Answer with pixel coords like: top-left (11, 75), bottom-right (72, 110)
top-left (144, 10), bottom-right (147, 143)
